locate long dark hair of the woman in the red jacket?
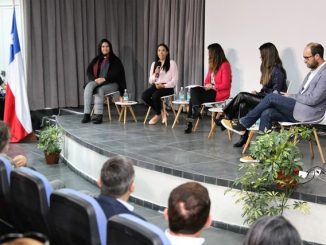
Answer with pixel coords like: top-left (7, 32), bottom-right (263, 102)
top-left (207, 43), bottom-right (228, 74)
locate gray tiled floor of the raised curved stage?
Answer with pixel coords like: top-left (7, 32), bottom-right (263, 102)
top-left (58, 105), bottom-right (326, 204)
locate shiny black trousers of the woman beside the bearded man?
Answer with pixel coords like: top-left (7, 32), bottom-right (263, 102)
top-left (223, 92), bottom-right (265, 120)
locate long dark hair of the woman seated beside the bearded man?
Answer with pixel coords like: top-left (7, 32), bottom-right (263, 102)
top-left (259, 43), bottom-right (286, 85)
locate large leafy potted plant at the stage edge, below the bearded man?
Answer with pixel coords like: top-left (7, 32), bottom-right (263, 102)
top-left (227, 127), bottom-right (312, 224)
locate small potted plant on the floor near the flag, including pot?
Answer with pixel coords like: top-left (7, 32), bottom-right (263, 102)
top-left (38, 125), bottom-right (62, 164)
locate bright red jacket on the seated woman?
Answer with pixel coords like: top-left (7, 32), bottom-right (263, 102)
top-left (204, 61), bottom-right (232, 101)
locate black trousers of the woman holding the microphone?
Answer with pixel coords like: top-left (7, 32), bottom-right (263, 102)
top-left (142, 85), bottom-right (174, 115)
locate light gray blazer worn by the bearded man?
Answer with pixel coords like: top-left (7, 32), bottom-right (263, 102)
top-left (290, 62), bottom-right (326, 122)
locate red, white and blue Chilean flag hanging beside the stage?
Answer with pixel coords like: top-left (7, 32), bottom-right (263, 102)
top-left (4, 9), bottom-right (32, 142)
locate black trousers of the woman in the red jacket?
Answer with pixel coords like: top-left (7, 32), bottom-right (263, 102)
top-left (188, 87), bottom-right (216, 118)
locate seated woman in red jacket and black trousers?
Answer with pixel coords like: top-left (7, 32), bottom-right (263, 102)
top-left (184, 43), bottom-right (232, 134)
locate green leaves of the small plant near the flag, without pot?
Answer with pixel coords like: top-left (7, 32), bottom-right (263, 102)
top-left (37, 125), bottom-right (62, 154)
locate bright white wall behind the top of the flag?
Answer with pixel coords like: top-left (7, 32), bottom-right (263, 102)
top-left (0, 0), bottom-right (25, 79)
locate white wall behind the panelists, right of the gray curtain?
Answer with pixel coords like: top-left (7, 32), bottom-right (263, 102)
top-left (205, 0), bottom-right (326, 96)
